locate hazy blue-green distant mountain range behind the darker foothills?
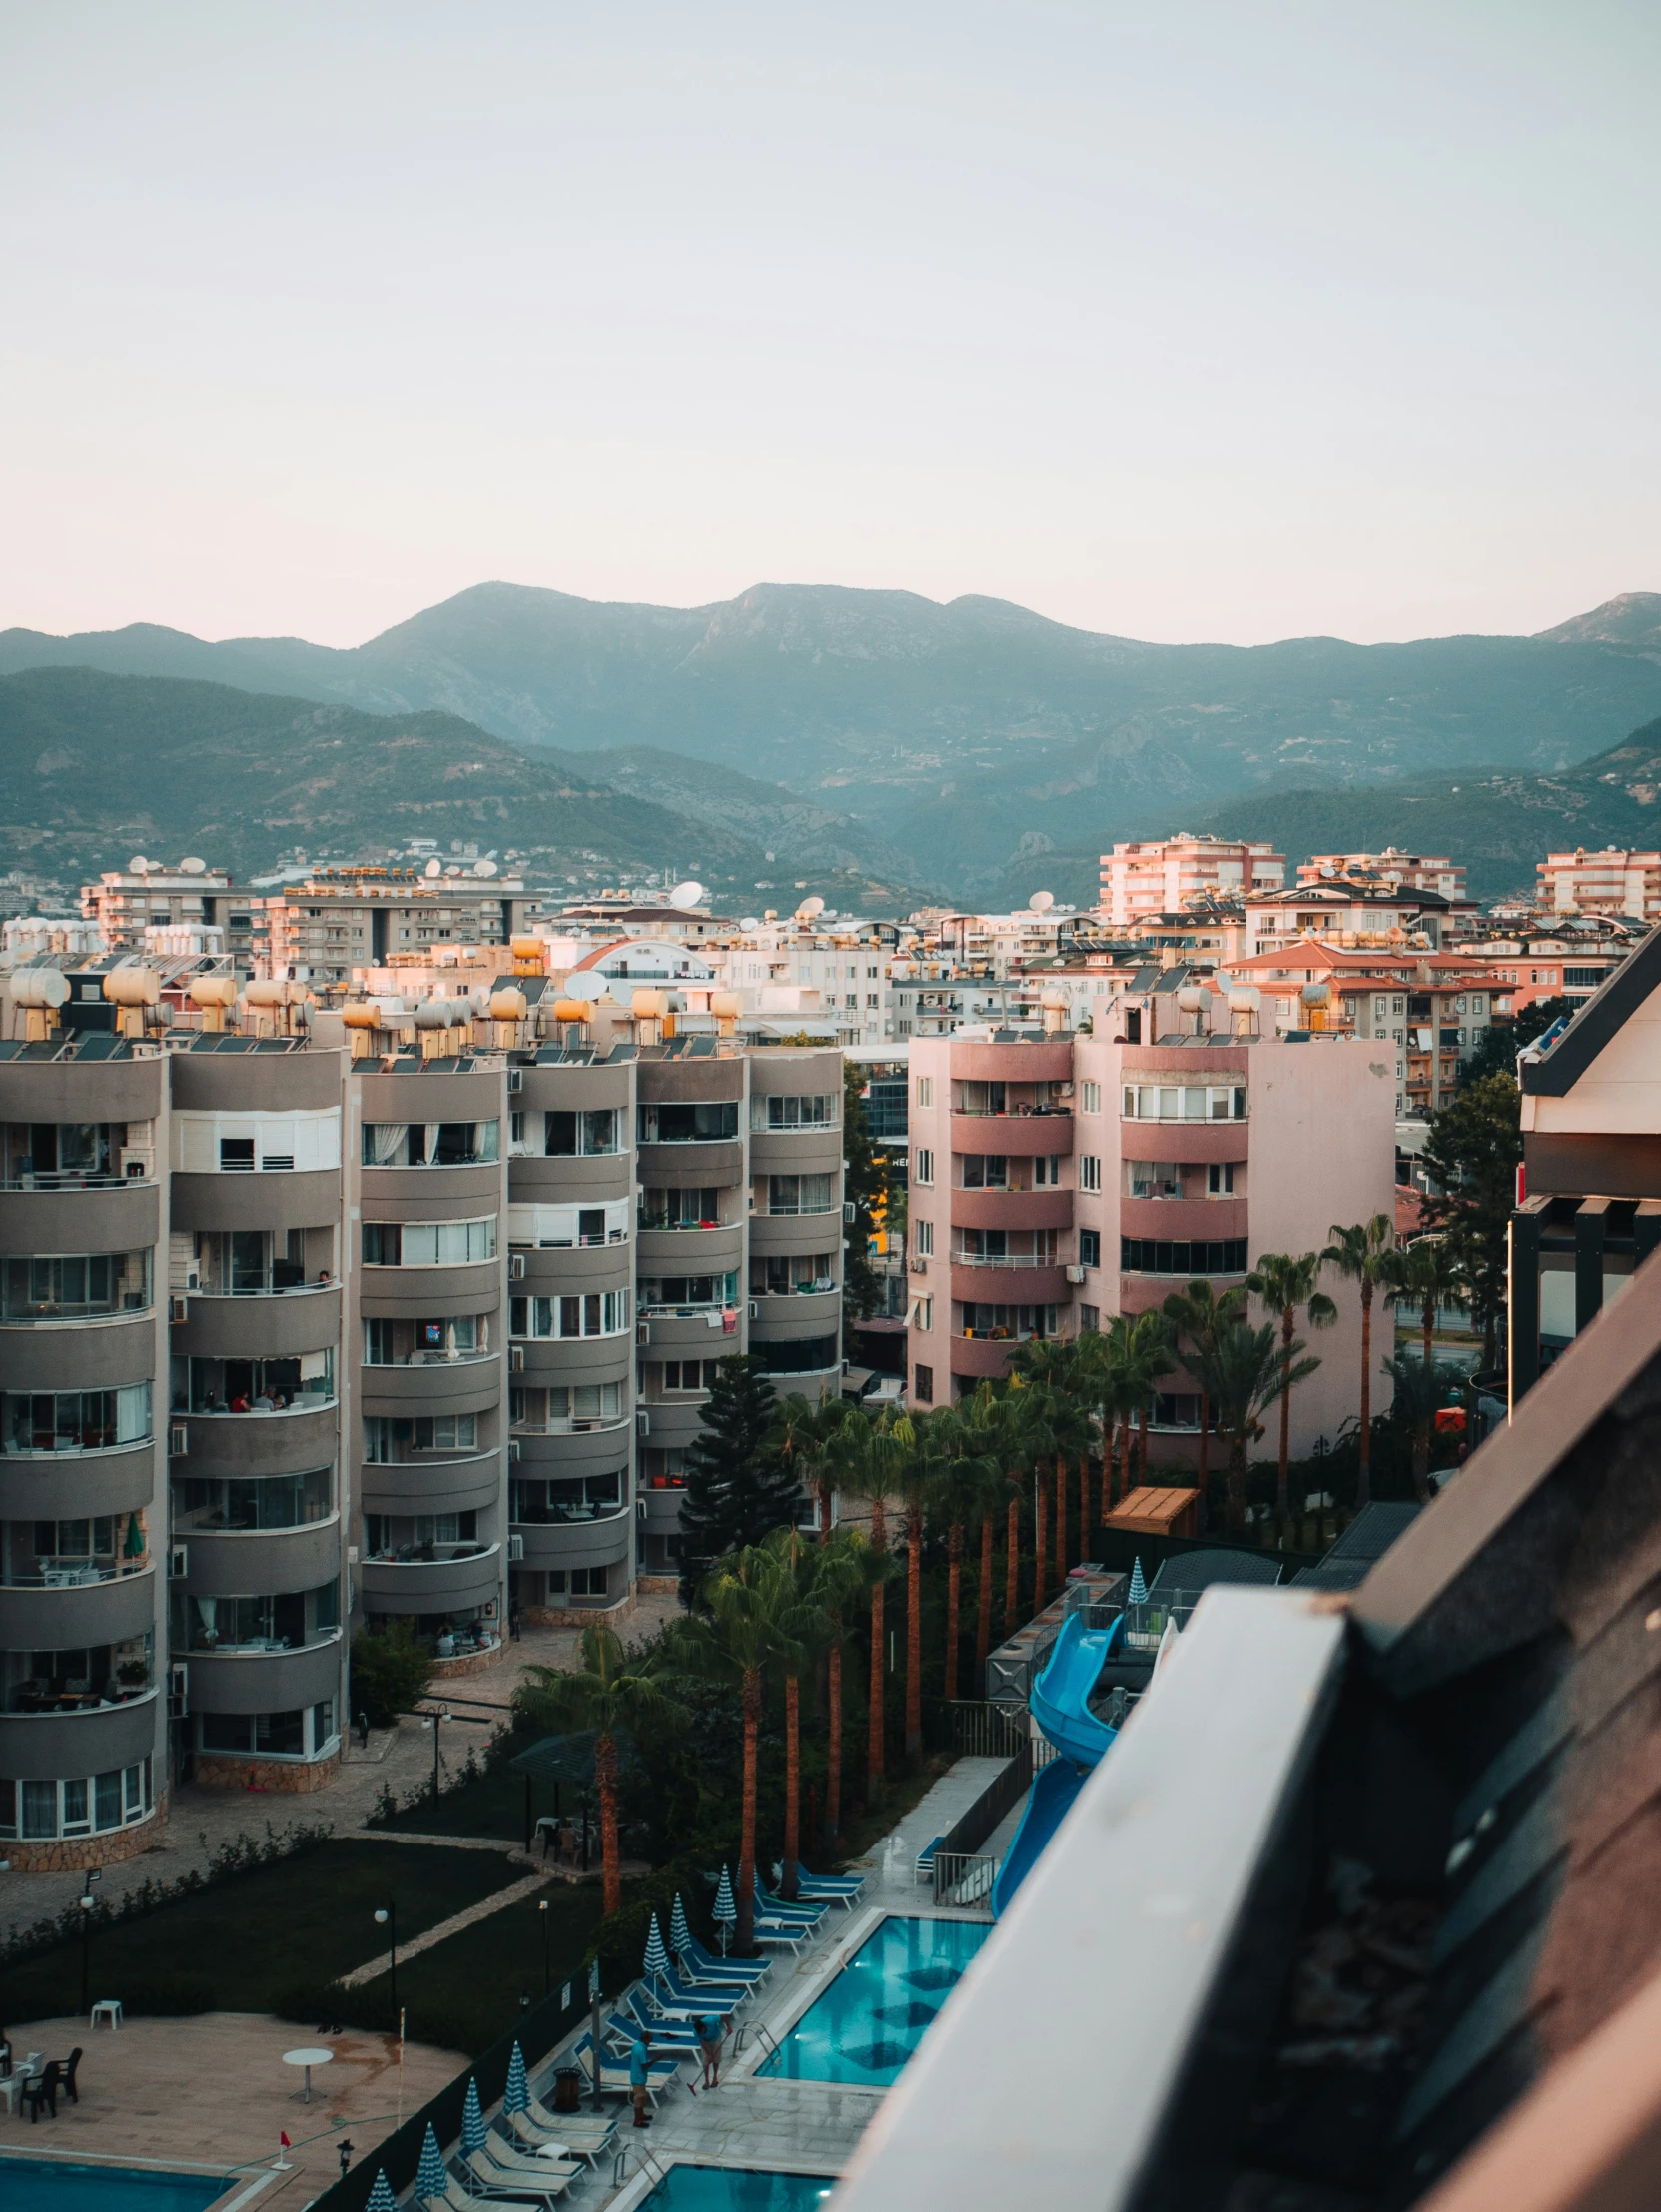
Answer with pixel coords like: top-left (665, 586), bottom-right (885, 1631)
top-left (0, 584), bottom-right (1661, 905)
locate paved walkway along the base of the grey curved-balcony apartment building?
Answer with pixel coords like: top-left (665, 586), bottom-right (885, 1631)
top-left (0, 1595), bottom-right (681, 1931)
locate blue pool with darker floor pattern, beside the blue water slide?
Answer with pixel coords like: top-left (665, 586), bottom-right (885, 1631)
top-left (756, 1915), bottom-right (991, 2088)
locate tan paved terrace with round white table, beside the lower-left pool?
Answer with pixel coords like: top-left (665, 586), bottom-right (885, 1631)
top-left (0, 2013), bottom-right (466, 2212)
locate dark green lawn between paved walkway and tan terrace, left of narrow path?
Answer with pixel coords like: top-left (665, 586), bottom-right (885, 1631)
top-left (0, 1843), bottom-right (524, 2022)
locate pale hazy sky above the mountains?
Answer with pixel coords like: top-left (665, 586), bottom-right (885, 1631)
top-left (0, 0), bottom-right (1661, 644)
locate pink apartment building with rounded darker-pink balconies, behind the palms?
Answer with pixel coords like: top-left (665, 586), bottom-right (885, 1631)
top-left (907, 1017), bottom-right (1395, 1462)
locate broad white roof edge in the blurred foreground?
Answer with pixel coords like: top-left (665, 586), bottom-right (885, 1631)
top-left (836, 1586), bottom-right (1344, 2212)
